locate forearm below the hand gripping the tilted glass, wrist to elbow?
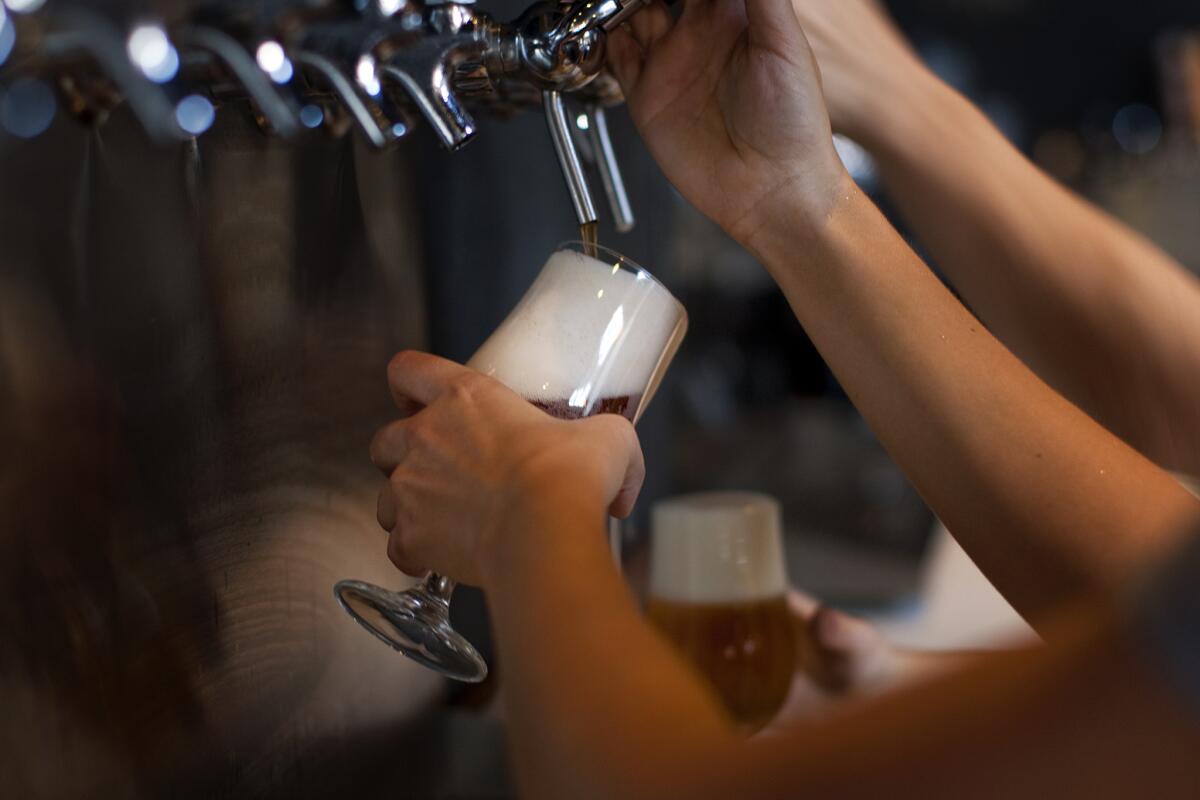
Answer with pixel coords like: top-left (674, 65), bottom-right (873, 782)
top-left (487, 499), bottom-right (737, 800)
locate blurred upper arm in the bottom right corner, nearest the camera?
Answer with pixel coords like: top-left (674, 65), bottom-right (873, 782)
top-left (739, 603), bottom-right (1200, 799)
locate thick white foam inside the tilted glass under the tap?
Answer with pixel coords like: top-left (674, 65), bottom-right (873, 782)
top-left (469, 251), bottom-right (682, 407)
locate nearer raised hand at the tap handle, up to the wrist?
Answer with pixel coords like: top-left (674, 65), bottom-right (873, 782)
top-left (608, 0), bottom-right (850, 245)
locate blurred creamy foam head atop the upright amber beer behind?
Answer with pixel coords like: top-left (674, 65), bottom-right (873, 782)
top-left (649, 492), bottom-right (787, 603)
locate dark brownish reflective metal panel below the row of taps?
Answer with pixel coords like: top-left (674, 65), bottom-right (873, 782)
top-left (0, 107), bottom-right (452, 798)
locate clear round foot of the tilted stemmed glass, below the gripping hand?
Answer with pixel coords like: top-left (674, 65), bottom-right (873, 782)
top-left (334, 581), bottom-right (487, 684)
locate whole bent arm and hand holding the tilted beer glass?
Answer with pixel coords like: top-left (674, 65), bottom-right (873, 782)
top-left (372, 352), bottom-right (1200, 800)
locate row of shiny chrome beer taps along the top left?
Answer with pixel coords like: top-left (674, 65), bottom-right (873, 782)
top-left (0, 0), bottom-right (641, 230)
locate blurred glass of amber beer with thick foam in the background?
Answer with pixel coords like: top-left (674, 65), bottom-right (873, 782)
top-left (647, 493), bottom-right (796, 730)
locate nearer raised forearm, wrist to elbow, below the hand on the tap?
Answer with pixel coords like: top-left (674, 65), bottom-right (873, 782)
top-left (749, 186), bottom-right (1198, 615)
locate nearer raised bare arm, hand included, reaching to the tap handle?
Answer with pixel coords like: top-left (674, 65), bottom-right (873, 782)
top-left (610, 0), bottom-right (1200, 624)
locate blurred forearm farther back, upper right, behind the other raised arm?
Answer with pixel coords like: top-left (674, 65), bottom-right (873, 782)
top-left (869, 76), bottom-right (1200, 473)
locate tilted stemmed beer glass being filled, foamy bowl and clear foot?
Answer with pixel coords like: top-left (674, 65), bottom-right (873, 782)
top-left (334, 242), bottom-right (688, 682)
